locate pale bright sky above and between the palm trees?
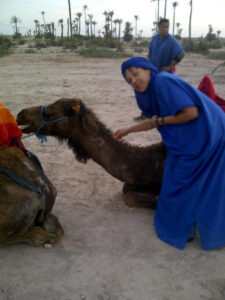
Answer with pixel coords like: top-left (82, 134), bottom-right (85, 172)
top-left (0, 0), bottom-right (225, 37)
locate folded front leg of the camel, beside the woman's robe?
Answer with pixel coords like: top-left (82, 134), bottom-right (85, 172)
top-left (123, 184), bottom-right (158, 209)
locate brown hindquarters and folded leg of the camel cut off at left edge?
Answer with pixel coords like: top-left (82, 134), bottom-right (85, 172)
top-left (0, 146), bottom-right (63, 246)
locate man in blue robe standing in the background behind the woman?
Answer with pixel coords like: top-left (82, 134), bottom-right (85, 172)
top-left (134, 19), bottom-right (185, 121)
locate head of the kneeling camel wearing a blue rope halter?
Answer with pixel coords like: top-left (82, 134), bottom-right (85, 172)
top-left (17, 98), bottom-right (102, 138)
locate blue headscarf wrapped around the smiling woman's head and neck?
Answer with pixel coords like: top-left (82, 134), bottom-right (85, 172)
top-left (121, 57), bottom-right (158, 117)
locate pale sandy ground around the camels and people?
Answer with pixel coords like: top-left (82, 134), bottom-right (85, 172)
top-left (0, 47), bottom-right (225, 300)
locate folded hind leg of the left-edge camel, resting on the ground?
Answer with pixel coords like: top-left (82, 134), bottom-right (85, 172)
top-left (0, 226), bottom-right (58, 246)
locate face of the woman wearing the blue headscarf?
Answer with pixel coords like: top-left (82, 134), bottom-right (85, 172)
top-left (125, 67), bottom-right (151, 93)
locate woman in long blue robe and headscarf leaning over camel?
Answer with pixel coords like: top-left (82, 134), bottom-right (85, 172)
top-left (114, 57), bottom-right (225, 250)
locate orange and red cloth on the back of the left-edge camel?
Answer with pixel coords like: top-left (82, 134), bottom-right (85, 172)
top-left (0, 102), bottom-right (24, 148)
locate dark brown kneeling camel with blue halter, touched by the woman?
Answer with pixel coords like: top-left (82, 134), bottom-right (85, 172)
top-left (17, 98), bottom-right (167, 208)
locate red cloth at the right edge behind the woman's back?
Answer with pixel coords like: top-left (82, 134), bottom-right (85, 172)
top-left (198, 75), bottom-right (225, 112)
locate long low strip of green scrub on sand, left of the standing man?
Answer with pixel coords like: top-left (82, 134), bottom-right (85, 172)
top-left (79, 47), bottom-right (132, 58)
